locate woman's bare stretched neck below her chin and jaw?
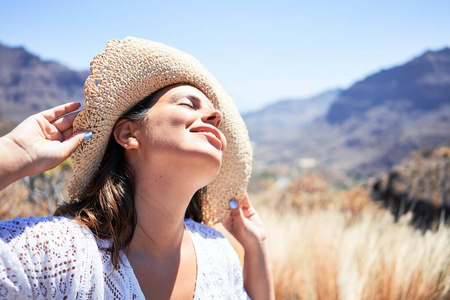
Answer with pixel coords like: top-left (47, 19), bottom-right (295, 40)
top-left (127, 165), bottom-right (197, 260)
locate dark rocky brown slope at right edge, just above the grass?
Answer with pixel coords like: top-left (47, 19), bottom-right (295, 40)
top-left (372, 140), bottom-right (450, 228)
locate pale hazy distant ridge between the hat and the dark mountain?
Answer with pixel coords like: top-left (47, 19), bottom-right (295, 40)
top-left (242, 89), bottom-right (341, 143)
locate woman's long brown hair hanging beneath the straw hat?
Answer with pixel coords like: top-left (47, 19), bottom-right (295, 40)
top-left (54, 91), bottom-right (206, 269)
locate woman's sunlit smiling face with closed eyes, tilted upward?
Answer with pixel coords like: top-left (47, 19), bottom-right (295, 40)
top-left (126, 85), bottom-right (226, 175)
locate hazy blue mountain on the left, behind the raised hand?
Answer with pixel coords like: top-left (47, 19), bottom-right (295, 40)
top-left (0, 44), bottom-right (89, 123)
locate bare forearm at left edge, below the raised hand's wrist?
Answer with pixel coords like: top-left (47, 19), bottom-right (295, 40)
top-left (0, 135), bottom-right (31, 190)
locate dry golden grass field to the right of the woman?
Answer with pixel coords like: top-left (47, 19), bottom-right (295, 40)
top-left (248, 175), bottom-right (450, 300)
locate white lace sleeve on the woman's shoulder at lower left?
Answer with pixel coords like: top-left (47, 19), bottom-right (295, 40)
top-left (0, 217), bottom-right (103, 299)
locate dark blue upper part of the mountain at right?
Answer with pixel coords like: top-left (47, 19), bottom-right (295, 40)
top-left (326, 48), bottom-right (450, 124)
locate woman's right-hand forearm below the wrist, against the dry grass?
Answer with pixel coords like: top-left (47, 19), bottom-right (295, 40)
top-left (244, 242), bottom-right (275, 300)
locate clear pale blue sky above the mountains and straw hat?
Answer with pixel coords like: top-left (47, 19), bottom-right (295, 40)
top-left (0, 0), bottom-right (450, 112)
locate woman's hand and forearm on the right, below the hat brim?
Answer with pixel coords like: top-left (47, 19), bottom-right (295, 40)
top-left (223, 192), bottom-right (275, 299)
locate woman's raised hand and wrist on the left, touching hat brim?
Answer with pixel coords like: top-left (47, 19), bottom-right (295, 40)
top-left (0, 102), bottom-right (92, 189)
